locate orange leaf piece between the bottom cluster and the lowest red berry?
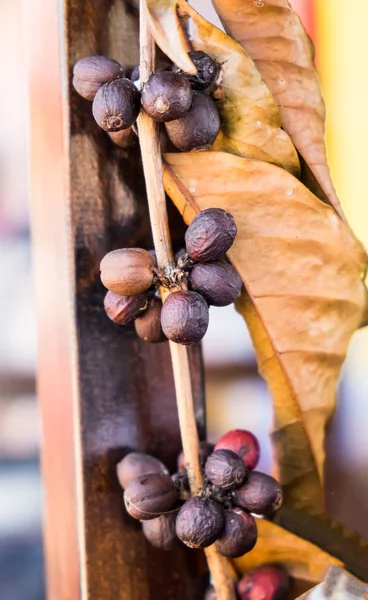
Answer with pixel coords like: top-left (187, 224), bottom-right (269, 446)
top-left (233, 519), bottom-right (342, 583)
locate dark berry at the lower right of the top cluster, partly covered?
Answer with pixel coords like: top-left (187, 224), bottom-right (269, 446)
top-left (165, 92), bottom-right (221, 152)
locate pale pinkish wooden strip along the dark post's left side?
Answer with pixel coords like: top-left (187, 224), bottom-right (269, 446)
top-left (23, 2), bottom-right (80, 600)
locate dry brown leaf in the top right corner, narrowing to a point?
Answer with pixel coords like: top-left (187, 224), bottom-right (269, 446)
top-left (212, 0), bottom-right (345, 218)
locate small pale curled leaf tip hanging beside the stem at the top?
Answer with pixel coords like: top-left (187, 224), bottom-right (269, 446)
top-left (146, 0), bottom-right (196, 74)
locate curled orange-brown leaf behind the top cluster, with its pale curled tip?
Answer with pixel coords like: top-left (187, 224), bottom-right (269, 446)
top-left (147, 0), bottom-right (300, 176)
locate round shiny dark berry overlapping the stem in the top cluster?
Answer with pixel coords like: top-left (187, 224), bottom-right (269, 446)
top-left (141, 71), bottom-right (192, 123)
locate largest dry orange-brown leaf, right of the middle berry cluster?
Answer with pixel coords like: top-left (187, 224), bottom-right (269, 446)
top-left (165, 152), bottom-right (366, 513)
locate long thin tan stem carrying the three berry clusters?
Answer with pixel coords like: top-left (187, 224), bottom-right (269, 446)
top-left (138, 0), bottom-right (235, 600)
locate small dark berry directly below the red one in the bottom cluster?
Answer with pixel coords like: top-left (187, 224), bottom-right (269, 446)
top-left (205, 450), bottom-right (247, 489)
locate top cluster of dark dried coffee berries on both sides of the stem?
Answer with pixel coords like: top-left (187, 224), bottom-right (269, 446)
top-left (73, 51), bottom-right (220, 152)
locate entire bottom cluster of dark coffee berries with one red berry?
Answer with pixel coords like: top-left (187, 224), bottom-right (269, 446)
top-left (118, 429), bottom-right (282, 558)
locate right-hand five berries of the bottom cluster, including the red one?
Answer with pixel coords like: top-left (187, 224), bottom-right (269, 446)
top-left (176, 430), bottom-right (282, 558)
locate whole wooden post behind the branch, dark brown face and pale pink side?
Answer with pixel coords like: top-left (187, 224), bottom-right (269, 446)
top-left (25, 0), bottom-right (206, 600)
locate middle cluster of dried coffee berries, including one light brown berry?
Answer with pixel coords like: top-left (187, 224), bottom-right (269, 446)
top-left (101, 208), bottom-right (242, 344)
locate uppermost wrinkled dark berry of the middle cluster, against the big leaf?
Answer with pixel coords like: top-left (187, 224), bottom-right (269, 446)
top-left (185, 208), bottom-right (237, 262)
